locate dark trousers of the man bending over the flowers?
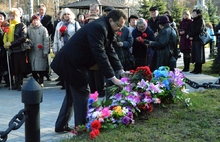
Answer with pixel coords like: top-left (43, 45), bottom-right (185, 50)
top-left (55, 83), bottom-right (90, 131)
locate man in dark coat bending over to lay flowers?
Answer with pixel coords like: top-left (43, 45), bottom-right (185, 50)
top-left (51, 10), bottom-right (127, 132)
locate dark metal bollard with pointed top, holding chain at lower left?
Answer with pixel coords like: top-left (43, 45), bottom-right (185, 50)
top-left (21, 77), bottom-right (43, 142)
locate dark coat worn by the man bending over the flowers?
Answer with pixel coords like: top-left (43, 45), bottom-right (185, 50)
top-left (51, 17), bottom-right (123, 87)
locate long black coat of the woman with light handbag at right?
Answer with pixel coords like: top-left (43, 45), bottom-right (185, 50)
top-left (188, 16), bottom-right (205, 63)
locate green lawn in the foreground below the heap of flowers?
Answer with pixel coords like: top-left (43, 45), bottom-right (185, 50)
top-left (61, 90), bottom-right (220, 142)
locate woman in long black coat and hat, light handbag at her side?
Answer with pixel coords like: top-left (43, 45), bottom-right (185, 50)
top-left (186, 9), bottom-right (205, 74)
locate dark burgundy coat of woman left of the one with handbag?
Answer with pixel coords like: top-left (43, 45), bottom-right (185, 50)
top-left (178, 19), bottom-right (192, 52)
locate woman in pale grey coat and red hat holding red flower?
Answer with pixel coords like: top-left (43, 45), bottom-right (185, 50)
top-left (27, 15), bottom-right (50, 87)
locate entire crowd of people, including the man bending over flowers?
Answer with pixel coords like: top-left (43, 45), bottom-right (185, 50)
top-left (0, 4), bottom-right (218, 132)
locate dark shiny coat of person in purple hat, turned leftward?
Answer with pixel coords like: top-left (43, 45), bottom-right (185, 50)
top-left (148, 25), bottom-right (178, 71)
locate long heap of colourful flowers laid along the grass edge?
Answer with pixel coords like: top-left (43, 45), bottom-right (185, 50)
top-left (70, 66), bottom-right (185, 139)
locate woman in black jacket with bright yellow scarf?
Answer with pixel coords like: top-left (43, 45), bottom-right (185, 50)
top-left (3, 8), bottom-right (27, 91)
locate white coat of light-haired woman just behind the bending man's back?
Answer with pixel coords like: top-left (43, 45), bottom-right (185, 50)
top-left (53, 21), bottom-right (80, 52)
